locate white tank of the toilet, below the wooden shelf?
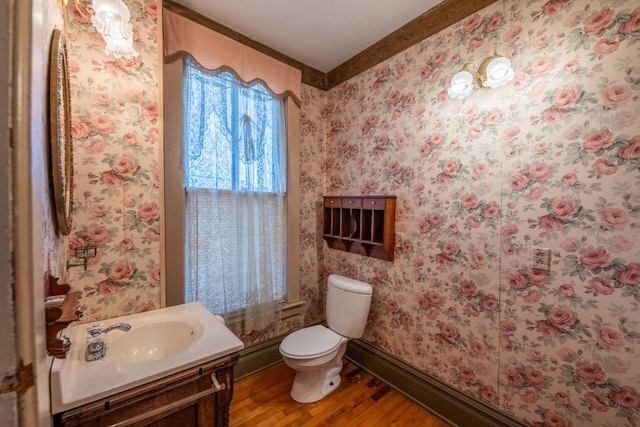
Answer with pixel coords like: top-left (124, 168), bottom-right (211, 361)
top-left (326, 274), bottom-right (373, 338)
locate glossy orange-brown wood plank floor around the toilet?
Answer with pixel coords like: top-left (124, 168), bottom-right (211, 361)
top-left (230, 363), bottom-right (448, 427)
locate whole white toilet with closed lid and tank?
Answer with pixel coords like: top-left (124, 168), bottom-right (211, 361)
top-left (280, 274), bottom-right (373, 403)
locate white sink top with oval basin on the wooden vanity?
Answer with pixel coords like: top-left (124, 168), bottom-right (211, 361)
top-left (50, 302), bottom-right (244, 414)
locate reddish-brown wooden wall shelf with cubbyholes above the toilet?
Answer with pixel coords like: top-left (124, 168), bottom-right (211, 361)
top-left (322, 196), bottom-right (396, 261)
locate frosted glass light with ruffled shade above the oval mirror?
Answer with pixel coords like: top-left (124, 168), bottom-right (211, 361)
top-left (74, 0), bottom-right (138, 59)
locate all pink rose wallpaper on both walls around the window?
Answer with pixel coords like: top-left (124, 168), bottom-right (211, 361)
top-left (63, 0), bottom-right (640, 426)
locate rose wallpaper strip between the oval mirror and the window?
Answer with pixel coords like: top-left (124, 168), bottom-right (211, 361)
top-left (67, 0), bottom-right (160, 321)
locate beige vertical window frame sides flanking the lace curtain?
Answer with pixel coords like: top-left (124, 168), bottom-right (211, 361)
top-left (161, 60), bottom-right (303, 319)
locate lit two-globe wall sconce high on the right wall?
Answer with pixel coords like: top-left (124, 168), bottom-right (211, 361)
top-left (447, 51), bottom-right (515, 99)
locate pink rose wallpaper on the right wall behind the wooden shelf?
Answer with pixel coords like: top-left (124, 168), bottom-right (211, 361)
top-left (323, 0), bottom-right (640, 427)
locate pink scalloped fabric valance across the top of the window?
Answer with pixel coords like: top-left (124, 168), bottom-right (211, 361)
top-left (163, 9), bottom-right (302, 100)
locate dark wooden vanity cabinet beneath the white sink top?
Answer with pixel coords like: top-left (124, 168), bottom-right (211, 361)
top-left (54, 353), bottom-right (238, 427)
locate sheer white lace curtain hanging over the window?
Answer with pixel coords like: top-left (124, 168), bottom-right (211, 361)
top-left (183, 60), bottom-right (286, 334)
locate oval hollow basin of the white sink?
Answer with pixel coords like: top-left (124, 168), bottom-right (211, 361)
top-left (107, 319), bottom-right (202, 363)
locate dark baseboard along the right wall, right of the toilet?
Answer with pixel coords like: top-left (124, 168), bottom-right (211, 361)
top-left (345, 340), bottom-right (527, 427)
